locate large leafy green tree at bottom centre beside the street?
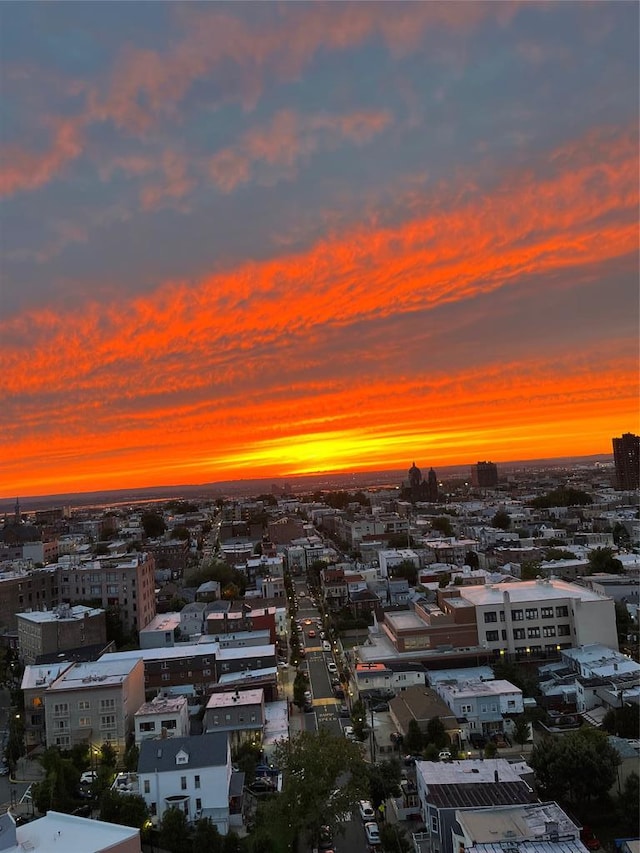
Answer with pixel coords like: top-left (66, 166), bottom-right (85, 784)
top-left (268, 728), bottom-right (367, 850)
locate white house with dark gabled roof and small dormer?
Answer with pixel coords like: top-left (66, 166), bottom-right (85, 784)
top-left (138, 732), bottom-right (232, 835)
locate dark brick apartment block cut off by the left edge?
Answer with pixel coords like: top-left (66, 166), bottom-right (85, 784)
top-left (0, 566), bottom-right (60, 633)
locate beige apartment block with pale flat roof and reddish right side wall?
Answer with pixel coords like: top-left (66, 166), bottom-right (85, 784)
top-left (43, 655), bottom-right (144, 752)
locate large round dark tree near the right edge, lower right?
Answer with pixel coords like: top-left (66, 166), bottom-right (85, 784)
top-left (529, 726), bottom-right (620, 805)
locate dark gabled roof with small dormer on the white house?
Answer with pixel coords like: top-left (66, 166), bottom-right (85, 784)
top-left (138, 732), bottom-right (228, 773)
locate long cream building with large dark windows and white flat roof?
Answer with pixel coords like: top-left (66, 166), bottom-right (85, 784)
top-left (459, 578), bottom-right (618, 657)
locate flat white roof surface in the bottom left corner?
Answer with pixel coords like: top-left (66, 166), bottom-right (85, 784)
top-left (11, 812), bottom-right (140, 853)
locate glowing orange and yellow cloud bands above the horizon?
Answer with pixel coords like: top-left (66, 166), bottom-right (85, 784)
top-left (0, 120), bottom-right (638, 494)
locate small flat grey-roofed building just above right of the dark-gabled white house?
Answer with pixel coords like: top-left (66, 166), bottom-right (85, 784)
top-left (203, 689), bottom-right (265, 747)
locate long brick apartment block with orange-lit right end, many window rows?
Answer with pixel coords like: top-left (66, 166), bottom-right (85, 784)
top-left (58, 552), bottom-right (156, 631)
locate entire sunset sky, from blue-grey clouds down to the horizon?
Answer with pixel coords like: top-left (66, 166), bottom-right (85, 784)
top-left (0, 0), bottom-right (640, 497)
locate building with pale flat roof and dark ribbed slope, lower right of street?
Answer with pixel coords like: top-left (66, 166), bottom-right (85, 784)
top-left (416, 758), bottom-right (536, 853)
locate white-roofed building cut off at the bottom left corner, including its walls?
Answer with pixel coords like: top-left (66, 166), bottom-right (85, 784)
top-left (0, 811), bottom-right (142, 853)
